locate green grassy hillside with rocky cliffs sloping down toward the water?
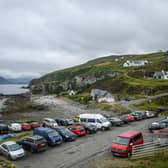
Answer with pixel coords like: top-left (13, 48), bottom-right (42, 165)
top-left (30, 52), bottom-right (168, 96)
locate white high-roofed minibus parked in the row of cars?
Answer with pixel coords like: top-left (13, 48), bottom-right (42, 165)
top-left (79, 114), bottom-right (111, 130)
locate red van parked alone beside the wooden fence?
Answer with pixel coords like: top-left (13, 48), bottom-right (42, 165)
top-left (111, 130), bottom-right (144, 157)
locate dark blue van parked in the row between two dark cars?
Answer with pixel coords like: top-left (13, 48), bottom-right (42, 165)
top-left (33, 127), bottom-right (63, 145)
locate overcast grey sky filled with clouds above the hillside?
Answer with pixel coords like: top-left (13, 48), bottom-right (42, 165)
top-left (0, 0), bottom-right (168, 77)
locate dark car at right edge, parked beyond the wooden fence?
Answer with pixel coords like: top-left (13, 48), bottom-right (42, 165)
top-left (149, 119), bottom-right (168, 132)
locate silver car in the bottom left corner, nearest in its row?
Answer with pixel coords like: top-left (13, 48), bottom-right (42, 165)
top-left (0, 141), bottom-right (25, 160)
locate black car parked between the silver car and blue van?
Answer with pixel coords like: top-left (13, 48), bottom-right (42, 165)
top-left (17, 135), bottom-right (48, 153)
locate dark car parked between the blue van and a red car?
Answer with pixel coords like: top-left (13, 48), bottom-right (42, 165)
top-left (53, 126), bottom-right (77, 141)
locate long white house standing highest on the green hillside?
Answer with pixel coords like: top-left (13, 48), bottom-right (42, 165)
top-left (123, 60), bottom-right (148, 67)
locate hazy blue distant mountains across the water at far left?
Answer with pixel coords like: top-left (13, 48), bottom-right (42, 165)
top-left (0, 77), bottom-right (32, 84)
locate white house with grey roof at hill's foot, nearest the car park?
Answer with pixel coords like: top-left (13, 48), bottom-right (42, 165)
top-left (91, 89), bottom-right (115, 103)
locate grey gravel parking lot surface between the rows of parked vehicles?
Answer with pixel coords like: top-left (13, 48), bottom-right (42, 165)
top-left (15, 118), bottom-right (158, 168)
